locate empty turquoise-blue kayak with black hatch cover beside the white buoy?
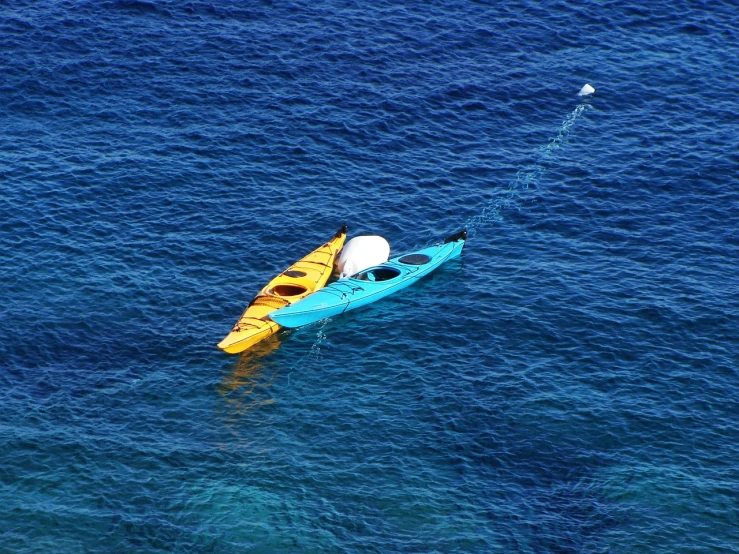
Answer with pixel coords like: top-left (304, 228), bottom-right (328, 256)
top-left (269, 230), bottom-right (467, 327)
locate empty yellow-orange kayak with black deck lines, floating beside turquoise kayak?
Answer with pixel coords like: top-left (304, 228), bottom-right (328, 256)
top-left (218, 225), bottom-right (346, 354)
